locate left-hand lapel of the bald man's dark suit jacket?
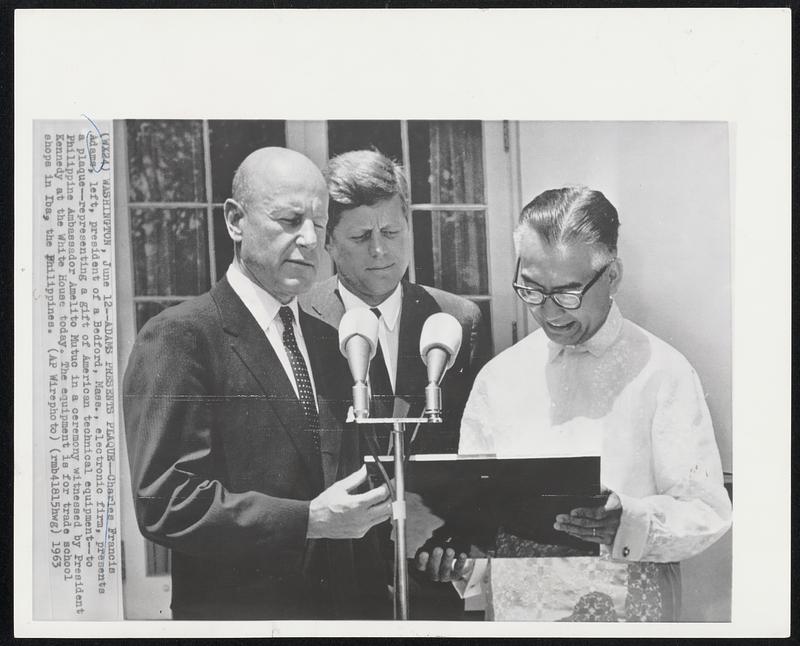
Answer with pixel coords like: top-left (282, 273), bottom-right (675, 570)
top-left (211, 279), bottom-right (322, 489)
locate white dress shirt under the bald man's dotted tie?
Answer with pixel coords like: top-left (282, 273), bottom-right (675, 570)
top-left (225, 261), bottom-right (317, 402)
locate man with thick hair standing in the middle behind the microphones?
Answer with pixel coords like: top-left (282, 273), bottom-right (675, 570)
top-left (301, 150), bottom-right (488, 453)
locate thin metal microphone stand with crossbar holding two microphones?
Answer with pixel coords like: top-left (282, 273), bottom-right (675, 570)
top-left (347, 416), bottom-right (442, 621)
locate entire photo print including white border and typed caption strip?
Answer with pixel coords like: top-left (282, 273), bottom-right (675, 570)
top-left (15, 10), bottom-right (790, 637)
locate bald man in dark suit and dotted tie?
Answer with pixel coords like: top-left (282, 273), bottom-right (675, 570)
top-left (123, 148), bottom-right (391, 619)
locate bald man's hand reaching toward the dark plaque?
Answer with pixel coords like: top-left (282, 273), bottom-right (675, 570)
top-left (307, 466), bottom-right (392, 538)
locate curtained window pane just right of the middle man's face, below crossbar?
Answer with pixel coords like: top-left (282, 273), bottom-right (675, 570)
top-left (414, 211), bottom-right (489, 295)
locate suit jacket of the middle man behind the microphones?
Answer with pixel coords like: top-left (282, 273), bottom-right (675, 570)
top-left (300, 276), bottom-right (488, 453)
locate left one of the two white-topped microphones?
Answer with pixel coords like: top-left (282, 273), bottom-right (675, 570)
top-left (339, 307), bottom-right (378, 417)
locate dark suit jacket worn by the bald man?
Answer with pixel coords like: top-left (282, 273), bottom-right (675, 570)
top-left (123, 279), bottom-right (386, 619)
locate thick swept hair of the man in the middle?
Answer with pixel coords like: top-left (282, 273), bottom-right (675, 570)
top-left (322, 150), bottom-right (408, 235)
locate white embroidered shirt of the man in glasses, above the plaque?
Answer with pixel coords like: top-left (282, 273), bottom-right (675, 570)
top-left (459, 303), bottom-right (731, 562)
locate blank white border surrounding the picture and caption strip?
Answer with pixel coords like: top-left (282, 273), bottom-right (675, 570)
top-left (14, 9), bottom-right (791, 637)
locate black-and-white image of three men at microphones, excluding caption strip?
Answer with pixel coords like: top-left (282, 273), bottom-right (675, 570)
top-left (115, 120), bottom-right (731, 621)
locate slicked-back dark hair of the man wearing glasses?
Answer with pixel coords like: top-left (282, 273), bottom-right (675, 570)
top-left (514, 186), bottom-right (619, 268)
